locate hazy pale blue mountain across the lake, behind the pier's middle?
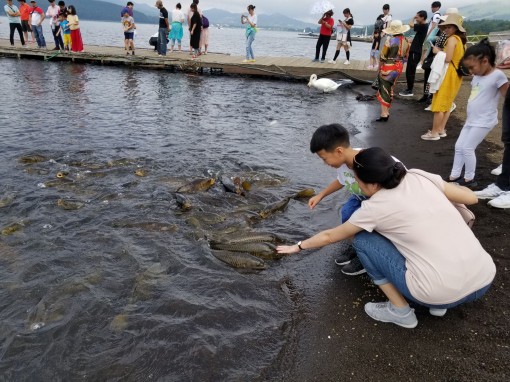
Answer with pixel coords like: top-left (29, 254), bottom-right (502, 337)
top-left (203, 8), bottom-right (317, 30)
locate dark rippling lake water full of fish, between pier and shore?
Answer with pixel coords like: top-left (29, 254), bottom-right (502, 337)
top-left (0, 17), bottom-right (378, 381)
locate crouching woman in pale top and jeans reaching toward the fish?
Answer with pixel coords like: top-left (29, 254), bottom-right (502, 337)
top-left (278, 147), bottom-right (496, 328)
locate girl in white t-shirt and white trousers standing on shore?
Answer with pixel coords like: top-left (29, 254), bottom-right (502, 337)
top-left (450, 38), bottom-right (508, 187)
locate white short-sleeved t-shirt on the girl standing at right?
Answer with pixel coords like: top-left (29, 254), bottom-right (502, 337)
top-left (466, 69), bottom-right (508, 129)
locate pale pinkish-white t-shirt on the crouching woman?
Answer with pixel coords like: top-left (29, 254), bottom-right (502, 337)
top-left (349, 169), bottom-right (496, 305)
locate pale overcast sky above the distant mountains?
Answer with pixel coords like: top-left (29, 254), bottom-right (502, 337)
top-left (134, 0), bottom-right (486, 24)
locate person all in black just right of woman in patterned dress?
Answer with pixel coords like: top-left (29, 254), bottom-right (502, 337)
top-left (399, 11), bottom-right (428, 97)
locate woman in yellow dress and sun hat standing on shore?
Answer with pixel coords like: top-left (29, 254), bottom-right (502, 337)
top-left (421, 14), bottom-right (467, 141)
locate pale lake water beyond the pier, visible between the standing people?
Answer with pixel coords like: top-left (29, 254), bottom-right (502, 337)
top-left (0, 17), bottom-right (371, 60)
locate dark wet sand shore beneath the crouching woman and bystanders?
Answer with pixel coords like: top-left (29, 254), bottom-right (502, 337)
top-left (268, 81), bottom-right (510, 381)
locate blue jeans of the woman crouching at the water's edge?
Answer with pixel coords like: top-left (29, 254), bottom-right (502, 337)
top-left (354, 231), bottom-right (490, 309)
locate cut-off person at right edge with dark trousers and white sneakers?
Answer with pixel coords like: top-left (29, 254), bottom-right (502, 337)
top-left (475, 83), bottom-right (510, 208)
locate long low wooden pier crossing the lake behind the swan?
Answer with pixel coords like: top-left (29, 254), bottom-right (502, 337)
top-left (0, 39), bottom-right (510, 84)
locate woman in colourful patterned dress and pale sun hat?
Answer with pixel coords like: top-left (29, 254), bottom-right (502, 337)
top-left (376, 20), bottom-right (410, 122)
